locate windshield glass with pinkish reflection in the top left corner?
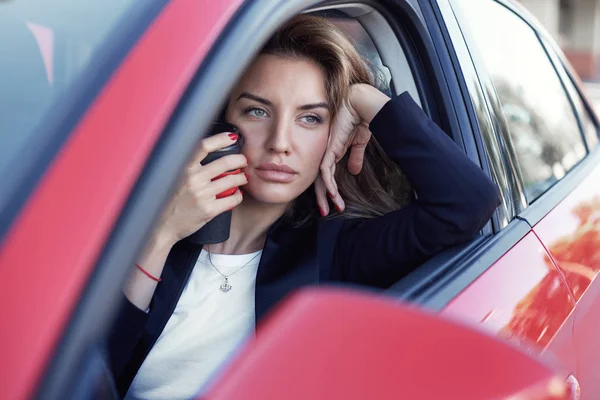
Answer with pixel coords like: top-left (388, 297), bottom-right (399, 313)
top-left (0, 0), bottom-right (136, 176)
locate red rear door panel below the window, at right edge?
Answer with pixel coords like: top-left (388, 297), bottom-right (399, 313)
top-left (534, 149), bottom-right (600, 399)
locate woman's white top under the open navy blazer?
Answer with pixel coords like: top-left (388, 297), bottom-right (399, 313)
top-left (125, 250), bottom-right (262, 400)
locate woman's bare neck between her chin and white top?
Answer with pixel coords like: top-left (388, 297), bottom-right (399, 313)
top-left (206, 193), bottom-right (288, 254)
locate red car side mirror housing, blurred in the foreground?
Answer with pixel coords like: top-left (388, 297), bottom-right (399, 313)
top-left (202, 289), bottom-right (574, 400)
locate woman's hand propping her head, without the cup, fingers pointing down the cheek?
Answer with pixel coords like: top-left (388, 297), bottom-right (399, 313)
top-left (315, 84), bottom-right (389, 216)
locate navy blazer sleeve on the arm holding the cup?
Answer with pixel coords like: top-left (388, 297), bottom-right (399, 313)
top-left (107, 294), bottom-right (148, 378)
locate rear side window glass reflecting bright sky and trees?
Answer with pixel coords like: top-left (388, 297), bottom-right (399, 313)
top-left (459, 0), bottom-right (586, 203)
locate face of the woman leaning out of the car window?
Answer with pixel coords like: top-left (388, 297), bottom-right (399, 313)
top-left (226, 55), bottom-right (330, 204)
